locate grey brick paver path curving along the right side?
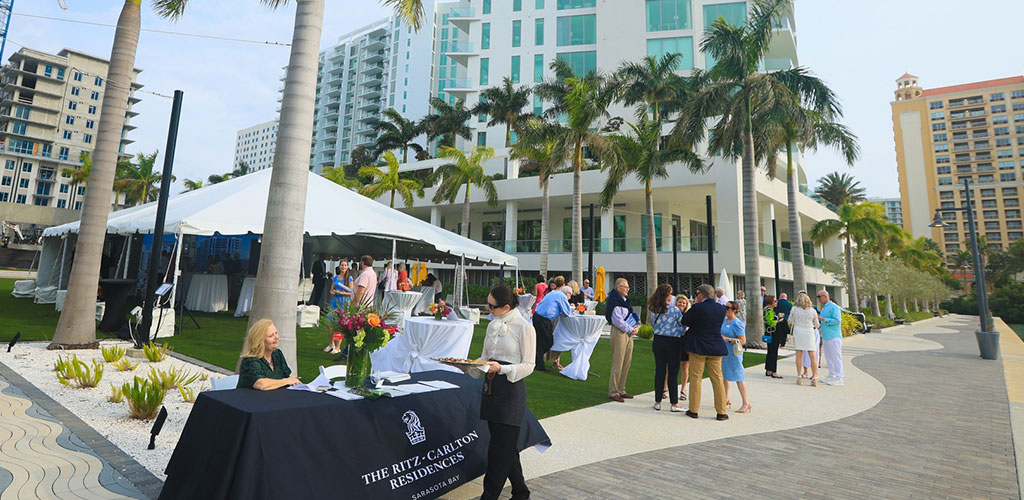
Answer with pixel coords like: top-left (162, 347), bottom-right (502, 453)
top-left (516, 319), bottom-right (1019, 500)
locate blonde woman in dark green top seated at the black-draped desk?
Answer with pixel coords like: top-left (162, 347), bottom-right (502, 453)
top-left (237, 319), bottom-right (299, 390)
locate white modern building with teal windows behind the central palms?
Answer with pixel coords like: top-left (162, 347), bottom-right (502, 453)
top-left (376, 0), bottom-right (845, 302)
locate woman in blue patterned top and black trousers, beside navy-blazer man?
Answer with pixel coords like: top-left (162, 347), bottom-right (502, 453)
top-left (647, 284), bottom-right (683, 412)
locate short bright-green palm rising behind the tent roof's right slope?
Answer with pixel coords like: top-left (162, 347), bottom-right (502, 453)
top-left (430, 145), bottom-right (498, 238)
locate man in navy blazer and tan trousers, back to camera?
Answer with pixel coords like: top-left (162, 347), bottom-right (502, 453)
top-left (683, 284), bottom-right (729, 420)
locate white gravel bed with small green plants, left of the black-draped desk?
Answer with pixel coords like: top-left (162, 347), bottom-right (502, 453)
top-left (0, 341), bottom-right (222, 481)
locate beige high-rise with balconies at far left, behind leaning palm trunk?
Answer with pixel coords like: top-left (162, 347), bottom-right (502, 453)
top-left (0, 48), bottom-right (141, 237)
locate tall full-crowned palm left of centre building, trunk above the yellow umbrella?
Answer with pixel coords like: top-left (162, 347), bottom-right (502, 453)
top-left (534, 59), bottom-right (616, 283)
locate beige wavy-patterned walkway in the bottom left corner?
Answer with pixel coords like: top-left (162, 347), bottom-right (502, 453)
top-left (0, 376), bottom-right (148, 500)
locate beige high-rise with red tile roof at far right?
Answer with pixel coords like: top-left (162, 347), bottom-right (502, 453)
top-left (892, 74), bottom-right (1024, 264)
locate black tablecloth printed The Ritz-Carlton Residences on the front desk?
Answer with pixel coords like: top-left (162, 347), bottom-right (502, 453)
top-left (160, 371), bottom-right (551, 500)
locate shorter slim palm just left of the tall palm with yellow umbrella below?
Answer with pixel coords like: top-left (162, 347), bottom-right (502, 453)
top-left (511, 119), bottom-right (565, 276)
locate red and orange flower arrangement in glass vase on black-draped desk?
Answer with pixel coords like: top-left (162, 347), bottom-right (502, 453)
top-left (335, 303), bottom-right (398, 387)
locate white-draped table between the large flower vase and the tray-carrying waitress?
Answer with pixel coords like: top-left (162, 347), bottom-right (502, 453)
top-left (370, 317), bottom-right (473, 373)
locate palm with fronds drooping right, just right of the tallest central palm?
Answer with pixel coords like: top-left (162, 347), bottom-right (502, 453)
top-left (756, 105), bottom-right (860, 290)
